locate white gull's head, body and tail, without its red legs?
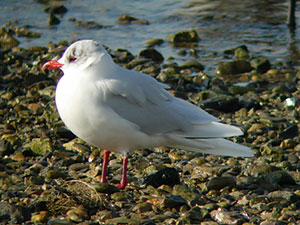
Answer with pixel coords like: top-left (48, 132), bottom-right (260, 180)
top-left (44, 40), bottom-right (253, 188)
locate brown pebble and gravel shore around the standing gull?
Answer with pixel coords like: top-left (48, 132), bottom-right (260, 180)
top-left (0, 21), bottom-right (300, 225)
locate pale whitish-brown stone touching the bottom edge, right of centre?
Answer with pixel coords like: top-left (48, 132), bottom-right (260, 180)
top-left (210, 209), bottom-right (245, 225)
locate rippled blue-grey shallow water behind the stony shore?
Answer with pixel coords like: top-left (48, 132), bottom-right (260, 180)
top-left (0, 0), bottom-right (300, 73)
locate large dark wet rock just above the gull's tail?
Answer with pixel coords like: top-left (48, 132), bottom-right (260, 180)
top-left (200, 94), bottom-right (240, 113)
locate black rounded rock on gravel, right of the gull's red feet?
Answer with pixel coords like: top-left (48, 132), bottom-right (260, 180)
top-left (144, 167), bottom-right (180, 188)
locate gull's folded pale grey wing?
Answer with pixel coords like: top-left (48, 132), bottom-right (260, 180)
top-left (98, 68), bottom-right (218, 136)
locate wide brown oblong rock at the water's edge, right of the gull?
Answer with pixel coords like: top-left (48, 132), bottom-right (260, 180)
top-left (216, 60), bottom-right (252, 76)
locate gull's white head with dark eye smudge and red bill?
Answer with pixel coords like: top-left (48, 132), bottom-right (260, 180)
top-left (42, 40), bottom-right (106, 70)
